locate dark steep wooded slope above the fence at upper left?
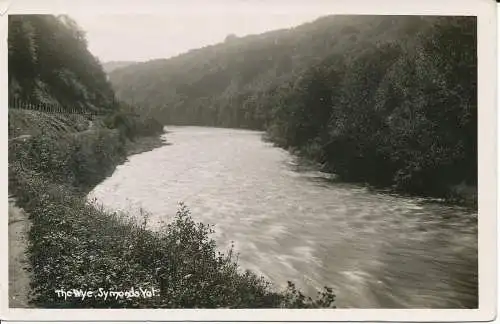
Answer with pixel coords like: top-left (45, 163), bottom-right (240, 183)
top-left (8, 15), bottom-right (115, 113)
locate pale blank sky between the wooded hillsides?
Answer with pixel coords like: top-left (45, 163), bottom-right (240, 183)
top-left (70, 12), bottom-right (321, 62)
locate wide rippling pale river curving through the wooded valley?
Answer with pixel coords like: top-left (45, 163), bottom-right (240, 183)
top-left (89, 127), bottom-right (478, 308)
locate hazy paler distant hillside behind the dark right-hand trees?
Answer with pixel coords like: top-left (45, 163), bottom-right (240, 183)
top-left (110, 16), bottom-right (432, 128)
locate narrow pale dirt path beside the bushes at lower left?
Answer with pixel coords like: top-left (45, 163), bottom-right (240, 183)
top-left (9, 197), bottom-right (31, 308)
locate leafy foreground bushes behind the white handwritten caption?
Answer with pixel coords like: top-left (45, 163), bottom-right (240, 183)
top-left (9, 173), bottom-right (334, 308)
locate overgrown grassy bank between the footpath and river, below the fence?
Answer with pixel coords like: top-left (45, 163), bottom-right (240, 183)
top-left (9, 112), bottom-right (334, 308)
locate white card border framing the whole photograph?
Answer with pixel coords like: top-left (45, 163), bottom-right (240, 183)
top-left (0, 0), bottom-right (498, 322)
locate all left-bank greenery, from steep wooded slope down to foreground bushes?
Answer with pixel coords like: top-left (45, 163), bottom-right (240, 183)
top-left (8, 16), bottom-right (335, 308)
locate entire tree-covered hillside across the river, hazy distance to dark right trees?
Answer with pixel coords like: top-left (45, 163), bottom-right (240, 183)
top-left (111, 16), bottom-right (477, 200)
